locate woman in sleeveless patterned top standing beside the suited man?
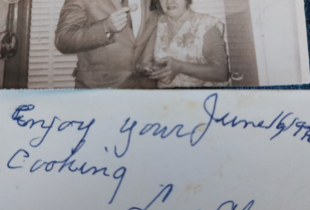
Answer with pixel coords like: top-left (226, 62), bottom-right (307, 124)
top-left (150, 0), bottom-right (229, 88)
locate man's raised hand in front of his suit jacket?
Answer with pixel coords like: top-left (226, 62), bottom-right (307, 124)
top-left (104, 7), bottom-right (130, 33)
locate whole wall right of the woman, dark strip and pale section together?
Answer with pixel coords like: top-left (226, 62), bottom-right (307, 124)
top-left (193, 0), bottom-right (309, 86)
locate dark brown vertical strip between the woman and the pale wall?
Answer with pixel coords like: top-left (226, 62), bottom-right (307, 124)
top-left (225, 0), bottom-right (259, 86)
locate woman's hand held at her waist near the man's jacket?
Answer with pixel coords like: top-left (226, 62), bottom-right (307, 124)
top-left (150, 57), bottom-right (180, 84)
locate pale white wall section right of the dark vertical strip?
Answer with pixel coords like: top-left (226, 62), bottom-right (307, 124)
top-left (250, 0), bottom-right (304, 85)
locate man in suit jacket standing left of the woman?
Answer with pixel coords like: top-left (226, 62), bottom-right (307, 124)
top-left (55, 0), bottom-right (158, 88)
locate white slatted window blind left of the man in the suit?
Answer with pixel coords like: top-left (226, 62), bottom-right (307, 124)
top-left (28, 0), bottom-right (77, 89)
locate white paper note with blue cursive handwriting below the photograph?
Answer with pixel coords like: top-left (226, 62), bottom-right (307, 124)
top-left (0, 90), bottom-right (310, 210)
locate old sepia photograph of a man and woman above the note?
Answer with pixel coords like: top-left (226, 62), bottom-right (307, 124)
top-left (0, 0), bottom-right (309, 89)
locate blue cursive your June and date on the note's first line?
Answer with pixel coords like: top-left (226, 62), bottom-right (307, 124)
top-left (114, 93), bottom-right (310, 158)
